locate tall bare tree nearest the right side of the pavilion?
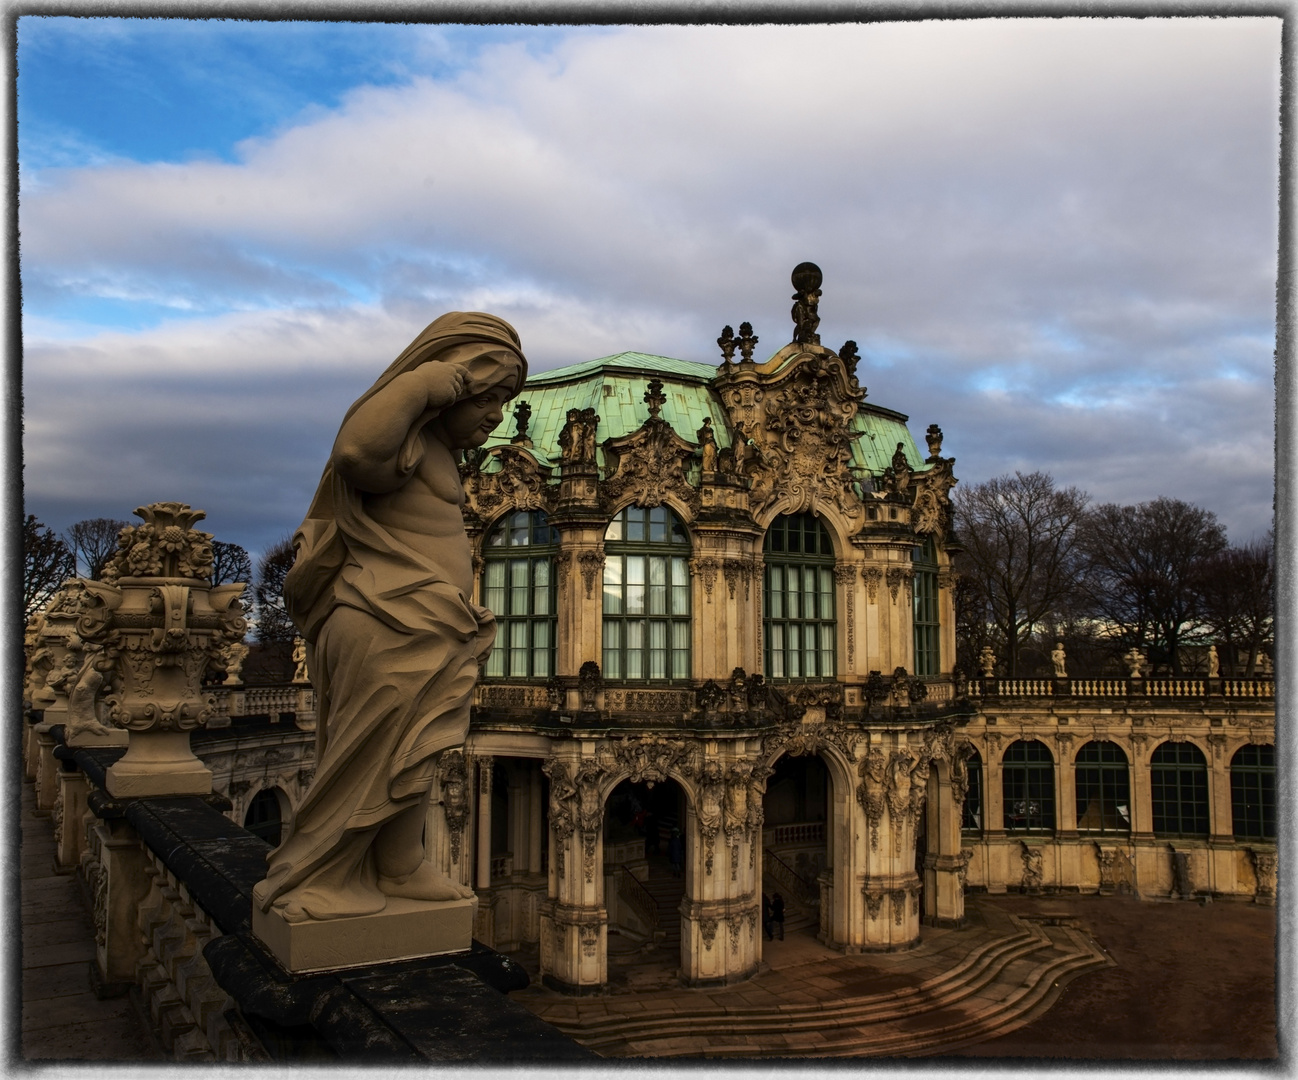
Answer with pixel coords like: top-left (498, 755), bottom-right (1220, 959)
top-left (955, 473), bottom-right (1088, 678)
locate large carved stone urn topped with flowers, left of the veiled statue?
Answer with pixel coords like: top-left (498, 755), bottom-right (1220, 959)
top-left (78, 502), bottom-right (247, 798)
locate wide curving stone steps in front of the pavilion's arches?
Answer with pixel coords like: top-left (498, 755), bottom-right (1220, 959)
top-left (530, 908), bottom-right (1111, 1058)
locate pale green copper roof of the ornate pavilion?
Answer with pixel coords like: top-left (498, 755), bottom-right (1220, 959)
top-left (487, 352), bottom-right (927, 476)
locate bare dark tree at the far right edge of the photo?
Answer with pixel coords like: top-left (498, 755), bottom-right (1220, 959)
top-left (1198, 532), bottom-right (1276, 675)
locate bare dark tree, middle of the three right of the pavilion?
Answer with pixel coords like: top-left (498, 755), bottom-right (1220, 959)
top-left (1083, 497), bottom-right (1225, 675)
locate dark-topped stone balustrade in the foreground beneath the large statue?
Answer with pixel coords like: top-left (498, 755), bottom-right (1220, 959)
top-left (34, 726), bottom-right (591, 1064)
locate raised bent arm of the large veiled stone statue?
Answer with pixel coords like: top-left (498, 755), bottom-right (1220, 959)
top-left (330, 362), bottom-right (465, 495)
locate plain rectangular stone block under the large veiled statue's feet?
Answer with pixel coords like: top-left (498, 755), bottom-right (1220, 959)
top-left (252, 897), bottom-right (478, 974)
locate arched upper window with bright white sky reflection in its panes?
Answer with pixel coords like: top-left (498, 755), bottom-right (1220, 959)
top-left (604, 506), bottom-right (689, 680)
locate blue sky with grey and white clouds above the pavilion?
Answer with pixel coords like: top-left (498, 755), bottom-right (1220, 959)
top-left (17, 16), bottom-right (1281, 553)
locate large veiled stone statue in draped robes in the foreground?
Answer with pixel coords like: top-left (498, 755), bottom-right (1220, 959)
top-left (253, 312), bottom-right (527, 923)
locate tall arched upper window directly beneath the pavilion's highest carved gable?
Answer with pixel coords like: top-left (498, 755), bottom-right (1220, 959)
top-left (762, 514), bottom-right (839, 679)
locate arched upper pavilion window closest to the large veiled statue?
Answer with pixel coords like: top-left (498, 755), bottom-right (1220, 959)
top-left (482, 510), bottom-right (559, 679)
